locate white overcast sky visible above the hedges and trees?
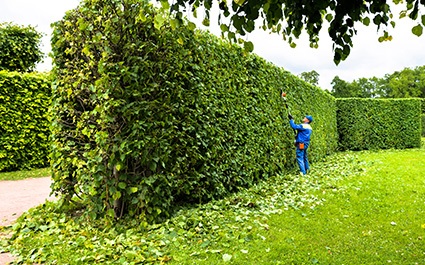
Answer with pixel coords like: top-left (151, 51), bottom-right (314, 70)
top-left (0, 0), bottom-right (425, 89)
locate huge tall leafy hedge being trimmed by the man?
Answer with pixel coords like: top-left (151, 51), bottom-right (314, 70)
top-left (48, 0), bottom-right (337, 221)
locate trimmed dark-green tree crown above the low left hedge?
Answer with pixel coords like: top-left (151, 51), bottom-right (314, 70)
top-left (0, 23), bottom-right (43, 72)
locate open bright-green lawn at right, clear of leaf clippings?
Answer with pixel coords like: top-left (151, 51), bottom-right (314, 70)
top-left (263, 150), bottom-right (425, 264)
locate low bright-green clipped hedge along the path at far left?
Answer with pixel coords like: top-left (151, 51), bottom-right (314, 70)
top-left (0, 71), bottom-right (51, 171)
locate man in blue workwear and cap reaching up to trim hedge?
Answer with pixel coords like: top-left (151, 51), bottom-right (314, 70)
top-left (288, 114), bottom-right (313, 175)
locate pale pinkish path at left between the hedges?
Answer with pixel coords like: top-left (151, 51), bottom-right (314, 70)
top-left (0, 177), bottom-right (53, 265)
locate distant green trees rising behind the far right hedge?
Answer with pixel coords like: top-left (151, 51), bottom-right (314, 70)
top-left (332, 66), bottom-right (425, 98)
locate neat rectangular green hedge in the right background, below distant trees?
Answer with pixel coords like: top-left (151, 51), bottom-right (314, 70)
top-left (337, 98), bottom-right (422, 150)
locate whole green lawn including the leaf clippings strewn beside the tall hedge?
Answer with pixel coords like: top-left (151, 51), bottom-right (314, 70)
top-left (0, 145), bottom-right (425, 264)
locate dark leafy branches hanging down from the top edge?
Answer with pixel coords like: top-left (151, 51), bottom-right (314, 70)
top-left (161, 0), bottom-right (425, 64)
